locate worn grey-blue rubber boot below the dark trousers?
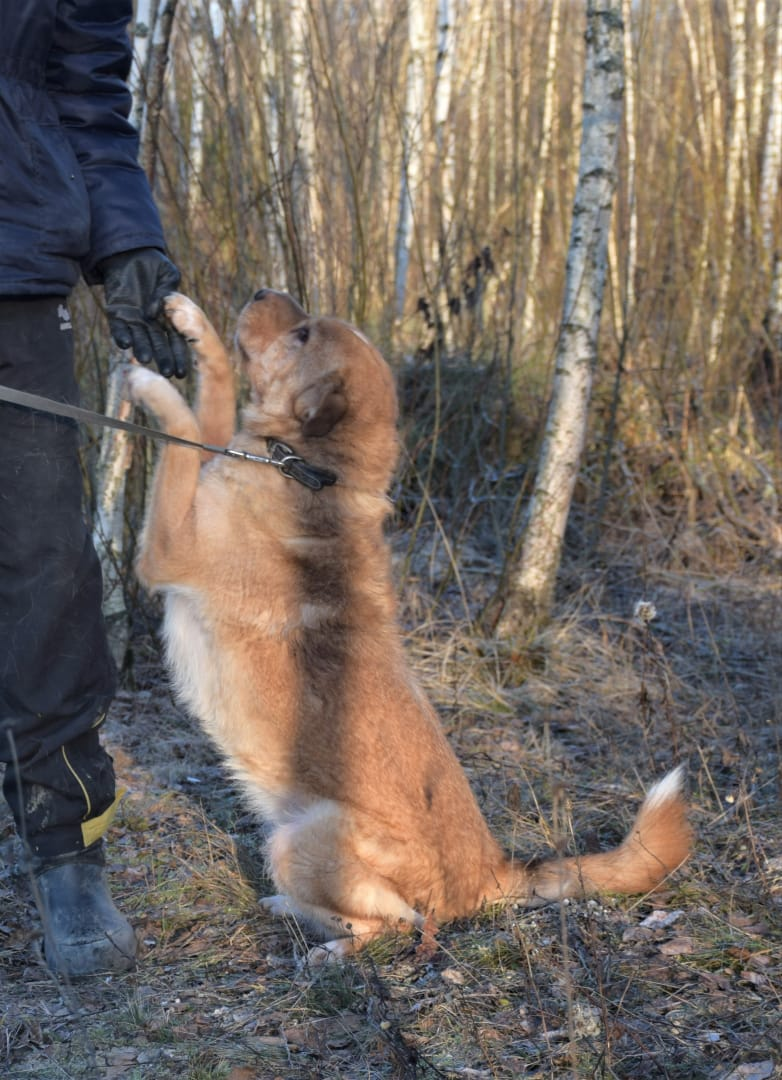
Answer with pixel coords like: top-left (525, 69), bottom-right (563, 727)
top-left (33, 845), bottom-right (137, 978)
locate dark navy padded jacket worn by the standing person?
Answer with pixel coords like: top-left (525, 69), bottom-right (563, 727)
top-left (0, 0), bottom-right (164, 296)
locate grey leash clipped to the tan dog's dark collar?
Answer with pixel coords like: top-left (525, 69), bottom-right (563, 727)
top-left (0, 386), bottom-right (337, 491)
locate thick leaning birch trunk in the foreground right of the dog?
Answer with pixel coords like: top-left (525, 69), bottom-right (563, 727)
top-left (498, 0), bottom-right (623, 638)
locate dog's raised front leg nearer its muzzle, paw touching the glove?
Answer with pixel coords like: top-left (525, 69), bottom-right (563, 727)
top-left (165, 293), bottom-right (237, 449)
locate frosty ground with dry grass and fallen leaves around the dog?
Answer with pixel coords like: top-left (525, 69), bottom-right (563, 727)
top-left (0, 552), bottom-right (782, 1080)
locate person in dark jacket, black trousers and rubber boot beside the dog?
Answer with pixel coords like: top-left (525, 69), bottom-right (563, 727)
top-left (0, 0), bottom-right (187, 977)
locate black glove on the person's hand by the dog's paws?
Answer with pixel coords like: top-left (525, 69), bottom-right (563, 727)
top-left (97, 247), bottom-right (190, 379)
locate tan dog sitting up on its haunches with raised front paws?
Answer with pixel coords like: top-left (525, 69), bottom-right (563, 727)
top-left (131, 289), bottom-right (690, 959)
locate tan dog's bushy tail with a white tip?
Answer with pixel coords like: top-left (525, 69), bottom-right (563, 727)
top-left (500, 767), bottom-right (692, 907)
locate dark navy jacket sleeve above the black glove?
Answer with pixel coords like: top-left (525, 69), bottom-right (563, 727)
top-left (46, 0), bottom-right (165, 284)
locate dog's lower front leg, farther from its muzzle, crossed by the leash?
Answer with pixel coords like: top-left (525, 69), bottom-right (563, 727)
top-left (127, 365), bottom-right (201, 589)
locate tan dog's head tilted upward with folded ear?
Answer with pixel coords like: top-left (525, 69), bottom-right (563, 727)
top-left (237, 288), bottom-right (396, 486)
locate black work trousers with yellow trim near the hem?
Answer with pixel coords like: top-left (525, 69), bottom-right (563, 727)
top-left (0, 297), bottom-right (114, 859)
